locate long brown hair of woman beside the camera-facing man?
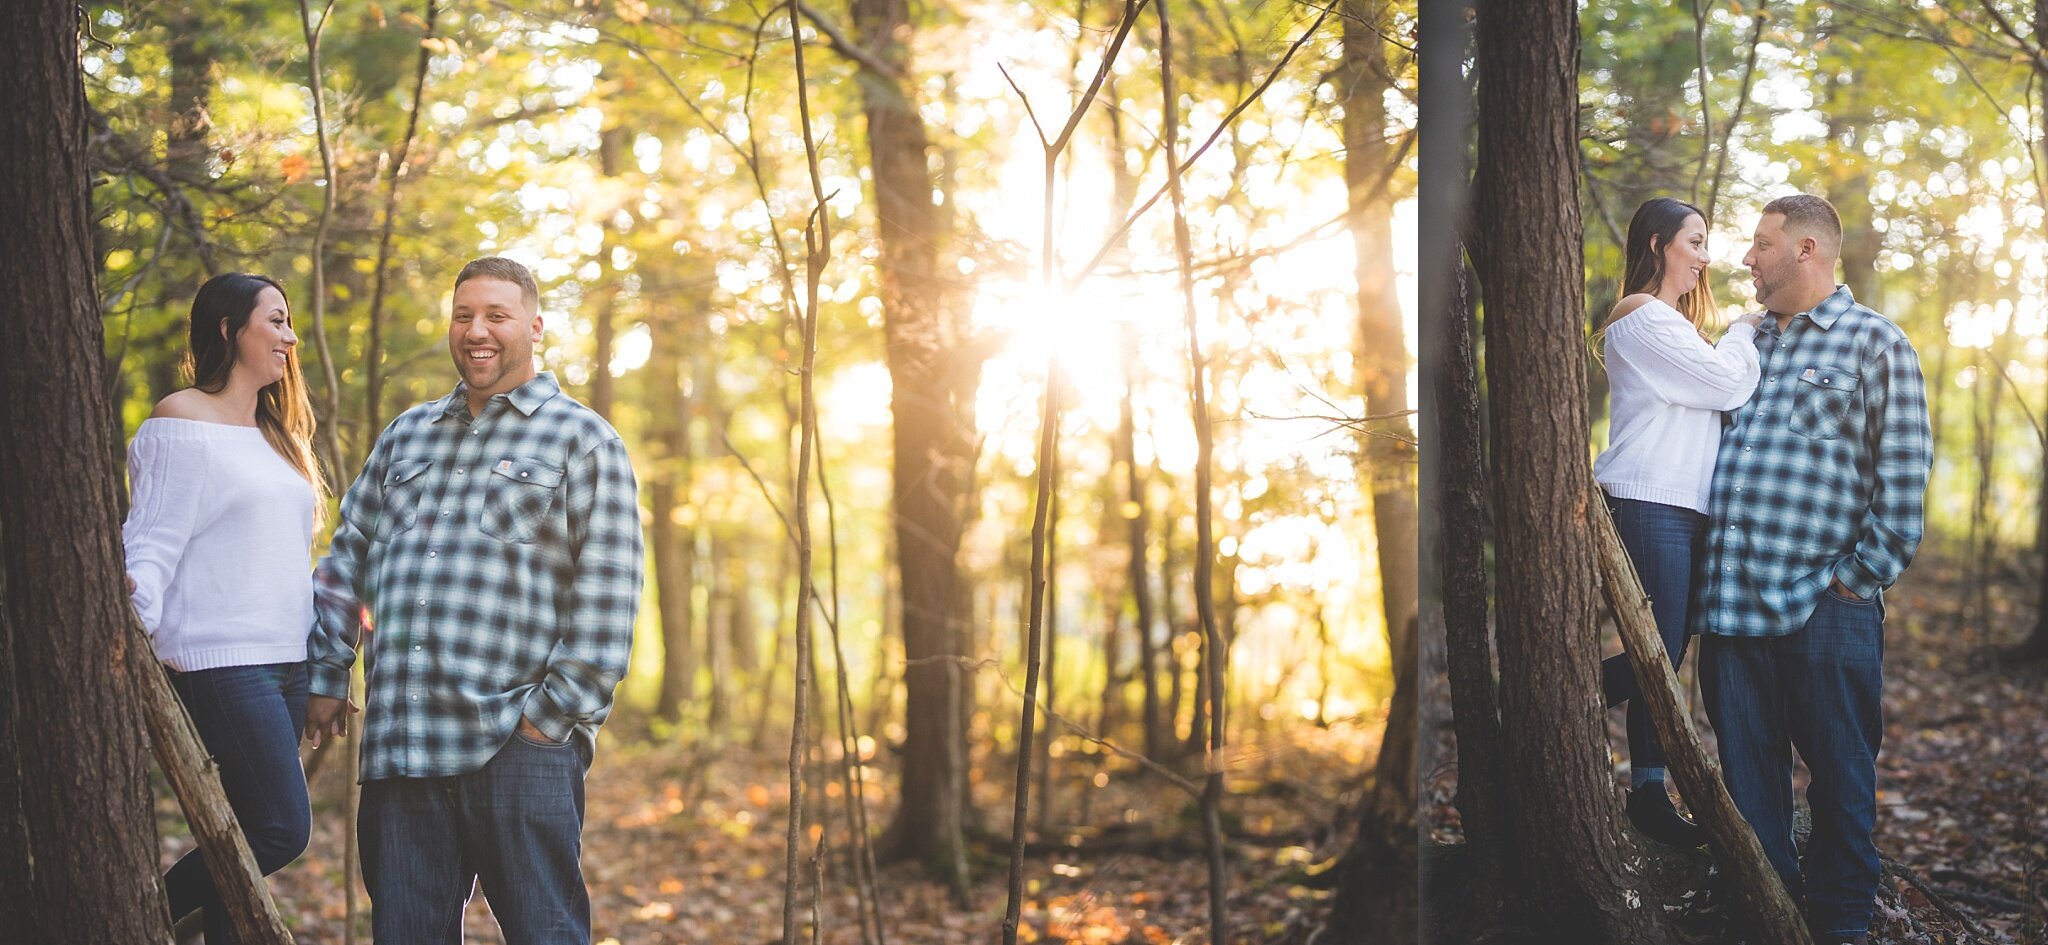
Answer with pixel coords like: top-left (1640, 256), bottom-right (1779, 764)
top-left (188, 273), bottom-right (328, 521)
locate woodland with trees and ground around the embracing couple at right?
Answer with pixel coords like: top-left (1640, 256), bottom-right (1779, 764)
top-left (1421, 0), bottom-right (2048, 943)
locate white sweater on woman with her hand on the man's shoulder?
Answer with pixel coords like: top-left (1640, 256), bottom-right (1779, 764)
top-left (1593, 299), bottom-right (1757, 512)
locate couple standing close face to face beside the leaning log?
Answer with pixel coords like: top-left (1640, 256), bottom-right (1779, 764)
top-left (1593, 195), bottom-right (1933, 945)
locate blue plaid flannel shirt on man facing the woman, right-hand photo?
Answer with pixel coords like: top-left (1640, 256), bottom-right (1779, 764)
top-left (1692, 287), bottom-right (1933, 638)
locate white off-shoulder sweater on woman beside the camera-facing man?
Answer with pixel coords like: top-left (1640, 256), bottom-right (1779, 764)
top-left (121, 418), bottom-right (313, 672)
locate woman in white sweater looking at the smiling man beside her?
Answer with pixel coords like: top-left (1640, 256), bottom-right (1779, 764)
top-left (121, 273), bottom-right (326, 943)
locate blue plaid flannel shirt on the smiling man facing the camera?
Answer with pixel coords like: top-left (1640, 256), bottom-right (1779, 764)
top-left (307, 373), bottom-right (641, 781)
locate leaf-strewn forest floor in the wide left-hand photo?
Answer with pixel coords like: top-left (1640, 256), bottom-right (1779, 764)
top-left (158, 705), bottom-right (1384, 945)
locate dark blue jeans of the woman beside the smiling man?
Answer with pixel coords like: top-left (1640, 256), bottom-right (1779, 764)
top-left (164, 662), bottom-right (313, 945)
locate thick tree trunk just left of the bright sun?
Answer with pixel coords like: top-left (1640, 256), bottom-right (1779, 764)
top-left (852, 0), bottom-right (973, 900)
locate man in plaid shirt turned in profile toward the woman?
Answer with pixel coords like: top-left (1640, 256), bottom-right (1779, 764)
top-left (1692, 195), bottom-right (1933, 943)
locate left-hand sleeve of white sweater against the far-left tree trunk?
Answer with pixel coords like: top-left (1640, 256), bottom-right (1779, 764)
top-left (121, 435), bottom-right (209, 638)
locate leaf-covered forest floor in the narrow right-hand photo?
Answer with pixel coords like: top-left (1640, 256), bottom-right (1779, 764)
top-left (1423, 560), bottom-right (2048, 945)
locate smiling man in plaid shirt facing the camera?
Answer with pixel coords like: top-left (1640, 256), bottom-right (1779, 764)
top-left (307, 256), bottom-right (641, 945)
